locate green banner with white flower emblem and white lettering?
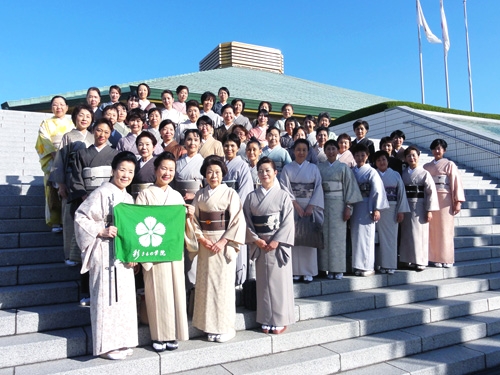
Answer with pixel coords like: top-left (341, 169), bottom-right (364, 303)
top-left (114, 203), bottom-right (186, 263)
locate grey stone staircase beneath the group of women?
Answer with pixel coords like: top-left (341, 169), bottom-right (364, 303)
top-left (0, 111), bottom-right (500, 375)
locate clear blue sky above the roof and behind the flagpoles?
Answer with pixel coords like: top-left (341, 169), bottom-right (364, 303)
top-left (0, 0), bottom-right (500, 113)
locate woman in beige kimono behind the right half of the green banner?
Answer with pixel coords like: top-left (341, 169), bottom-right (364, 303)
top-left (135, 152), bottom-right (194, 352)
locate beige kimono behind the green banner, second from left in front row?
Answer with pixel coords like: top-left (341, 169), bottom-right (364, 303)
top-left (135, 186), bottom-right (189, 341)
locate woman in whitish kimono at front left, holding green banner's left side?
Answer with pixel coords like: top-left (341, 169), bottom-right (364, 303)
top-left (75, 151), bottom-right (138, 359)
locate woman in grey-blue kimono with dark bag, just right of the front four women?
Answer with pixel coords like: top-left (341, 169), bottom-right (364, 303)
top-left (280, 139), bottom-right (324, 283)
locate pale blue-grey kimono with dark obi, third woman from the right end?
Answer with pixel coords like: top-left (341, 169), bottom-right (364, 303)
top-left (375, 168), bottom-right (410, 270)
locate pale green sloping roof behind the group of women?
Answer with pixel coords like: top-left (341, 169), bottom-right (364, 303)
top-left (2, 67), bottom-right (390, 117)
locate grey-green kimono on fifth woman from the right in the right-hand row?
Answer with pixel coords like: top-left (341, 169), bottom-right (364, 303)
top-left (318, 160), bottom-right (363, 273)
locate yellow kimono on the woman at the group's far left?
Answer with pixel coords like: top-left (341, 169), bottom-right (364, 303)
top-left (35, 116), bottom-right (75, 226)
